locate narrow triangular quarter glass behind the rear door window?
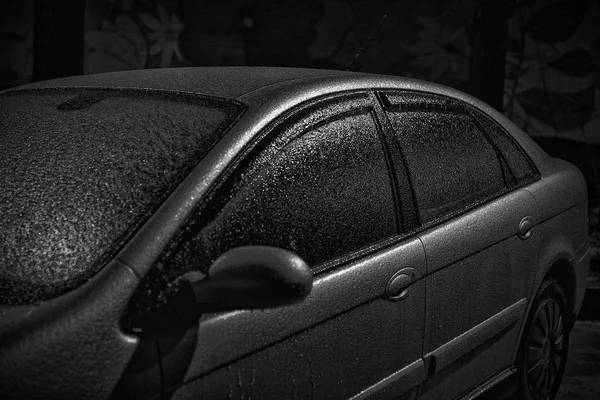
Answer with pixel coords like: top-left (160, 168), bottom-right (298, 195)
top-left (475, 112), bottom-right (537, 184)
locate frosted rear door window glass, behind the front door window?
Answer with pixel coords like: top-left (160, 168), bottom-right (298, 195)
top-left (388, 109), bottom-right (504, 223)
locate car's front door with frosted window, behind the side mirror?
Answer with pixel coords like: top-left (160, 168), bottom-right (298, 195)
top-left (142, 94), bottom-right (425, 399)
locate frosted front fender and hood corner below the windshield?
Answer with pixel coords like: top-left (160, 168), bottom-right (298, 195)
top-left (0, 261), bottom-right (139, 399)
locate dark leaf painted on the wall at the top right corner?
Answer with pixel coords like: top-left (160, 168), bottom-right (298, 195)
top-left (525, 0), bottom-right (586, 44)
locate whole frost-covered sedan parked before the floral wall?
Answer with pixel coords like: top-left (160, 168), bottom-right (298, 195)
top-left (0, 67), bottom-right (590, 399)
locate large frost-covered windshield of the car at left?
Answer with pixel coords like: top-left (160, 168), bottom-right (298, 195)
top-left (0, 89), bottom-right (242, 304)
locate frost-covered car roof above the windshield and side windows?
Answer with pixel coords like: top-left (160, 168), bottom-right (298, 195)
top-left (6, 66), bottom-right (484, 105)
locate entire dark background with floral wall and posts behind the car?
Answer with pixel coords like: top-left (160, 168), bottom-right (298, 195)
top-left (0, 0), bottom-right (600, 275)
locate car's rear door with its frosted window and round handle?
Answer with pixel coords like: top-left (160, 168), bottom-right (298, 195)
top-left (383, 93), bottom-right (537, 399)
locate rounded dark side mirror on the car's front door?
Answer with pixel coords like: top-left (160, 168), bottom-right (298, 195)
top-left (189, 246), bottom-right (313, 312)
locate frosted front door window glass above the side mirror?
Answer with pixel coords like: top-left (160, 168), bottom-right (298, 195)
top-left (168, 108), bottom-right (396, 275)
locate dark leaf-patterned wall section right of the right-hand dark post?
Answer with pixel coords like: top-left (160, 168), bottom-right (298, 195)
top-left (504, 1), bottom-right (600, 143)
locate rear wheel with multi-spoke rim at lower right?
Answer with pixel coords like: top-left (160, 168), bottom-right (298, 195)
top-left (516, 280), bottom-right (571, 400)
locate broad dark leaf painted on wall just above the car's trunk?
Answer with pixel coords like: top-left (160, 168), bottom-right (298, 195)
top-left (517, 86), bottom-right (595, 130)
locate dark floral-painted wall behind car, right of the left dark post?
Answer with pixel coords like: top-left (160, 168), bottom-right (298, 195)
top-left (84, 0), bottom-right (600, 144)
